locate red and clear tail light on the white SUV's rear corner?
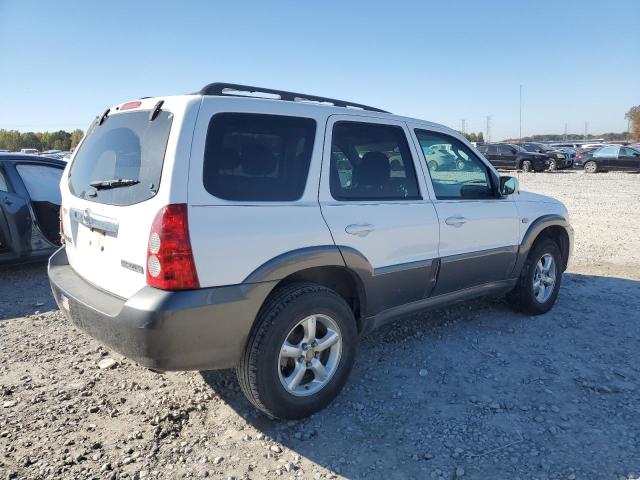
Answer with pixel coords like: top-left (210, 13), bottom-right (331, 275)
top-left (147, 203), bottom-right (200, 290)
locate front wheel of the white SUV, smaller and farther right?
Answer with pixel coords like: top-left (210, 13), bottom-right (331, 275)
top-left (507, 238), bottom-right (562, 315)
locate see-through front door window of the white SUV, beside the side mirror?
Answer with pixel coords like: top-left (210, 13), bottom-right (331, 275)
top-left (416, 130), bottom-right (494, 200)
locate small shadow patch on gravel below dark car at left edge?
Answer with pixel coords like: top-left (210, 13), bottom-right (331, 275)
top-left (0, 260), bottom-right (58, 321)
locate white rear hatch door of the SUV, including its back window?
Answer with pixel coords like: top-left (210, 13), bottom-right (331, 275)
top-left (61, 99), bottom-right (188, 298)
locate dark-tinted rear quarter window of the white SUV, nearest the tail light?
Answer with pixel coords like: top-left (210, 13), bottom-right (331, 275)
top-left (202, 113), bottom-right (316, 202)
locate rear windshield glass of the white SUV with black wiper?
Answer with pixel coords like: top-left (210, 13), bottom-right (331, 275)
top-left (69, 111), bottom-right (173, 205)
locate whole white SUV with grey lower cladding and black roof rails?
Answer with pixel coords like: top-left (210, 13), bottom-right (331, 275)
top-left (49, 84), bottom-right (573, 418)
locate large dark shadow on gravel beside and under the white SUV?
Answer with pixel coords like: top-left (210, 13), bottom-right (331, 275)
top-left (201, 274), bottom-right (640, 478)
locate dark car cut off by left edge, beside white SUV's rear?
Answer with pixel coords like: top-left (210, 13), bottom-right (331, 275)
top-left (0, 153), bottom-right (65, 264)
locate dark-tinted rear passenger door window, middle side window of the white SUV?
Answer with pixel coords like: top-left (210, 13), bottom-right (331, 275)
top-left (330, 122), bottom-right (421, 201)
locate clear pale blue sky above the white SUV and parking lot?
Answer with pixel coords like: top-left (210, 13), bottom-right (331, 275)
top-left (0, 0), bottom-right (640, 140)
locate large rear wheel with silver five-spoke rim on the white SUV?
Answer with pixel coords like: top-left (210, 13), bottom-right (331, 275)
top-left (236, 283), bottom-right (358, 419)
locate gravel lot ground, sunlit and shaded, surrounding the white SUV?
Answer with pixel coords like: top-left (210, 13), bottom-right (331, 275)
top-left (0, 172), bottom-right (640, 479)
